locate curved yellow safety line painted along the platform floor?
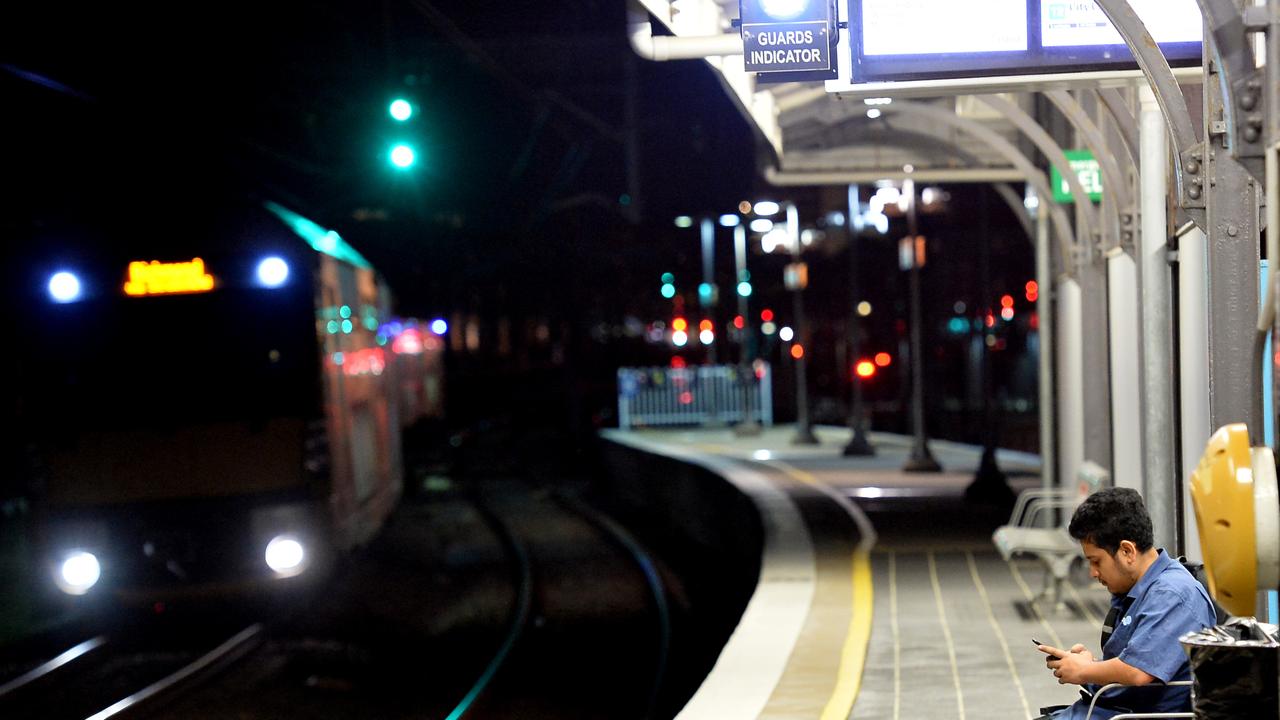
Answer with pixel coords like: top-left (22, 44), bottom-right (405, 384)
top-left (769, 460), bottom-right (876, 720)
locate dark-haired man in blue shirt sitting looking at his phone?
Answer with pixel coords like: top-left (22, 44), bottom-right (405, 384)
top-left (1038, 488), bottom-right (1216, 720)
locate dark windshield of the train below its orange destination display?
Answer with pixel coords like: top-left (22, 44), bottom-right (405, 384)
top-left (23, 280), bottom-right (319, 434)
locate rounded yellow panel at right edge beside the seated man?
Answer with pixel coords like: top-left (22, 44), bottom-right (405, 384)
top-left (1192, 424), bottom-right (1258, 615)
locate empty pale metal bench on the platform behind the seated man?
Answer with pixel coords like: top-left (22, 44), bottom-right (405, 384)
top-left (992, 462), bottom-right (1110, 610)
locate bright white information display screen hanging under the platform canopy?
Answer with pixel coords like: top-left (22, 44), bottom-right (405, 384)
top-left (849, 0), bottom-right (1203, 82)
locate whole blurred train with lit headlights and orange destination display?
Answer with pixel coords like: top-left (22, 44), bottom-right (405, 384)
top-left (18, 200), bottom-right (444, 610)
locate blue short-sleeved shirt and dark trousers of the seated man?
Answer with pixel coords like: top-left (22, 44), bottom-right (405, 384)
top-left (1065, 550), bottom-right (1217, 720)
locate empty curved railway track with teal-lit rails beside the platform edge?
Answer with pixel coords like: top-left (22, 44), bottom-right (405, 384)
top-left (448, 481), bottom-right (672, 720)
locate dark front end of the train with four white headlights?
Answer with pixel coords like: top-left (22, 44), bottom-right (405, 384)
top-left (20, 233), bottom-right (332, 609)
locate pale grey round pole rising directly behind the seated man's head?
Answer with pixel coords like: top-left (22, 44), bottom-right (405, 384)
top-left (1137, 87), bottom-right (1178, 553)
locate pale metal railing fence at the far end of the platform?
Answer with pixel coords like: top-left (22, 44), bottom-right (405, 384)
top-left (618, 361), bottom-right (773, 430)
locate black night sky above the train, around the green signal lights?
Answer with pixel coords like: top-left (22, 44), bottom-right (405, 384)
top-left (0, 0), bottom-right (754, 319)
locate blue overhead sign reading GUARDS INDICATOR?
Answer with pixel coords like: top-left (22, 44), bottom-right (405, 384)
top-left (740, 0), bottom-right (836, 73)
